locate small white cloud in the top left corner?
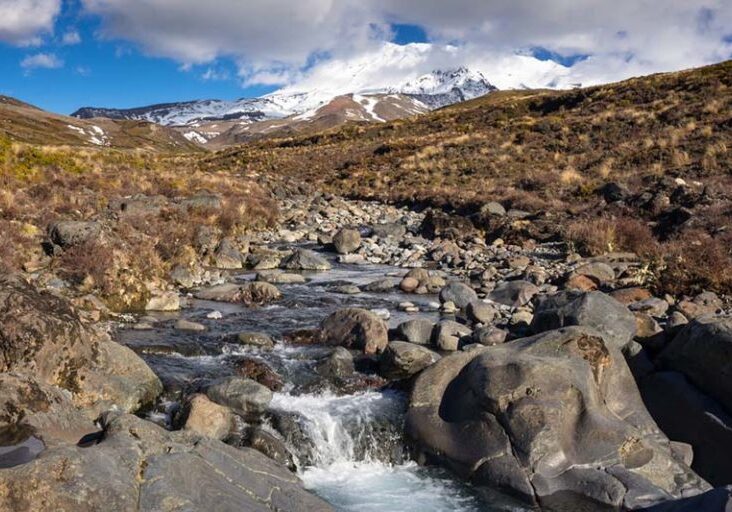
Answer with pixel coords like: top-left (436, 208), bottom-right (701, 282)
top-left (0, 0), bottom-right (61, 46)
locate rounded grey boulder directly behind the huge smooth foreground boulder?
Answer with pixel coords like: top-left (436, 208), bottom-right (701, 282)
top-left (531, 291), bottom-right (636, 349)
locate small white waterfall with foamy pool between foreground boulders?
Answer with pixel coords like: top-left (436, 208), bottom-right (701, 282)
top-left (272, 391), bottom-right (490, 512)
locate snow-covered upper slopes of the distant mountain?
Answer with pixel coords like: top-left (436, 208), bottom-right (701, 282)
top-left (72, 67), bottom-right (496, 127)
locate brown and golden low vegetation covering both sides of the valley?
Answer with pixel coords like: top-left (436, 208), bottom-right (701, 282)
top-left (0, 62), bottom-right (732, 293)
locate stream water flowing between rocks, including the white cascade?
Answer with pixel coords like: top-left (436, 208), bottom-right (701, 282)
top-left (118, 253), bottom-right (532, 512)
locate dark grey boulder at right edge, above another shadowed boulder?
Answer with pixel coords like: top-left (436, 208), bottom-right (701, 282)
top-left (659, 316), bottom-right (732, 414)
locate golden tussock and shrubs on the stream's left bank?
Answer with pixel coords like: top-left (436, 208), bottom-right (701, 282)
top-left (0, 136), bottom-right (277, 309)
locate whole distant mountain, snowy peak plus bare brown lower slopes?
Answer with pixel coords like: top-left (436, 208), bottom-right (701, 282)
top-left (72, 67), bottom-right (497, 144)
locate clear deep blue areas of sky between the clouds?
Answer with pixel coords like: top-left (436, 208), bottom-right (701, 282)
top-left (0, 18), bottom-right (427, 114)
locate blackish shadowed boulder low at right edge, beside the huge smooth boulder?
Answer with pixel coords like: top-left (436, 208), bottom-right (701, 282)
top-left (640, 372), bottom-right (732, 485)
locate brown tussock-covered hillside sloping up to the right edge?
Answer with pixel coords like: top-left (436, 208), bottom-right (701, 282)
top-left (202, 62), bottom-right (732, 290)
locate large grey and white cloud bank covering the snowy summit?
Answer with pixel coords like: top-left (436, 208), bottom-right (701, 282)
top-left (80, 0), bottom-right (732, 87)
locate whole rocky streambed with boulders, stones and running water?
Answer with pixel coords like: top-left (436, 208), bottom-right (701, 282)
top-left (0, 195), bottom-right (732, 511)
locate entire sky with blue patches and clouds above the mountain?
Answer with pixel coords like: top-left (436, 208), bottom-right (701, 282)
top-left (0, 0), bottom-right (732, 114)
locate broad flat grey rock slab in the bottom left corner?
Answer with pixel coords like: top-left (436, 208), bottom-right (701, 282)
top-left (0, 415), bottom-right (332, 512)
